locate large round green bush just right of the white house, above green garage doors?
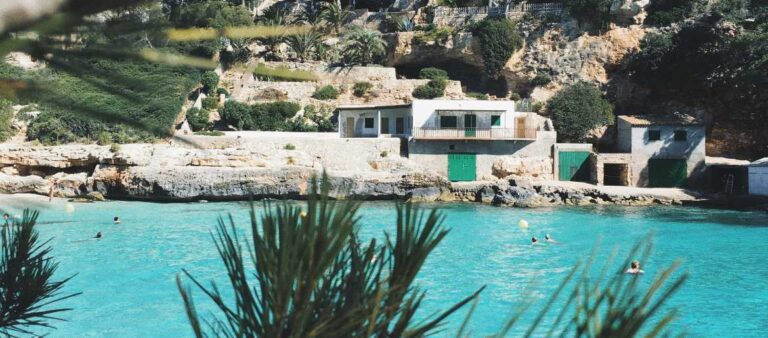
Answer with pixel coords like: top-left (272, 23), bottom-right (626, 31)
top-left (547, 82), bottom-right (613, 142)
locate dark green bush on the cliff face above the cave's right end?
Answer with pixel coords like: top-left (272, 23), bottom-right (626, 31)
top-left (474, 18), bottom-right (523, 78)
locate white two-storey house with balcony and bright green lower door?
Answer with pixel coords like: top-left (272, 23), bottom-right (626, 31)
top-left (338, 100), bottom-right (557, 181)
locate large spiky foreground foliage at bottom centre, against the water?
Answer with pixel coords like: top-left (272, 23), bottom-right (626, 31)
top-left (177, 177), bottom-right (482, 337)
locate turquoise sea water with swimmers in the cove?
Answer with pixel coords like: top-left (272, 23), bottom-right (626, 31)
top-left (6, 202), bottom-right (768, 337)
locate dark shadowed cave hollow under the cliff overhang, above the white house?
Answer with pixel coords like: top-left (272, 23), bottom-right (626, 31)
top-left (394, 60), bottom-right (508, 97)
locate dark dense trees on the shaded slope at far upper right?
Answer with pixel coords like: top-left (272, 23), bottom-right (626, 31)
top-left (629, 1), bottom-right (768, 158)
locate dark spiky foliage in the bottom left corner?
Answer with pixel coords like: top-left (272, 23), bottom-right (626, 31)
top-left (0, 210), bottom-right (79, 336)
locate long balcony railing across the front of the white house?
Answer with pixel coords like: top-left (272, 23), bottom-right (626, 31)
top-left (413, 128), bottom-right (536, 140)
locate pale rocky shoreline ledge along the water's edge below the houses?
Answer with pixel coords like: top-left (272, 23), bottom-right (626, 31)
top-left (0, 134), bottom-right (700, 207)
